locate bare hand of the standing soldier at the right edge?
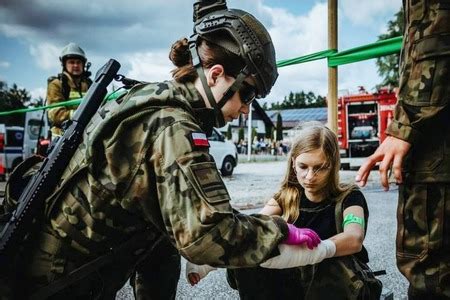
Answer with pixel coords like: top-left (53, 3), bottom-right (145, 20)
top-left (355, 136), bottom-right (411, 191)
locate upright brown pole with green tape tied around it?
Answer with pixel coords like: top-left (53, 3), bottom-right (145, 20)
top-left (327, 0), bottom-right (338, 133)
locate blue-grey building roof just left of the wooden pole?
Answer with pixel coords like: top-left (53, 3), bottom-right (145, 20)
top-left (266, 107), bottom-right (327, 128)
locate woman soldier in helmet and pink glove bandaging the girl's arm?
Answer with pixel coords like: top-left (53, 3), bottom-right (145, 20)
top-left (1, 1), bottom-right (320, 299)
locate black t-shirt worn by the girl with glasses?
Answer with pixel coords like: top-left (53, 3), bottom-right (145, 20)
top-left (294, 190), bottom-right (369, 262)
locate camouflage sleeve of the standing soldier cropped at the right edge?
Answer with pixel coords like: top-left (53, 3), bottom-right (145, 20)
top-left (387, 8), bottom-right (450, 144)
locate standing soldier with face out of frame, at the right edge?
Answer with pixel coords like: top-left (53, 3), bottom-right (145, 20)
top-left (356, 0), bottom-right (450, 299)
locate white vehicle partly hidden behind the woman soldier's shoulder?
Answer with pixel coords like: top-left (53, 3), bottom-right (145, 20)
top-left (208, 128), bottom-right (238, 176)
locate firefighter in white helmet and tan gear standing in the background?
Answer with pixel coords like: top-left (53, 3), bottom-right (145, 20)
top-left (47, 43), bottom-right (92, 136)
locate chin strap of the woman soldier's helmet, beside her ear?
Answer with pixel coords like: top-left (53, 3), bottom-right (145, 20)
top-left (189, 34), bottom-right (225, 128)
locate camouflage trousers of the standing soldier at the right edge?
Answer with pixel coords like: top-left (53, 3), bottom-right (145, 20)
top-left (397, 183), bottom-right (450, 299)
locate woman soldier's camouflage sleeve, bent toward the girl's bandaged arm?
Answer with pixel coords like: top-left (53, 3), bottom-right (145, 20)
top-left (151, 118), bottom-right (287, 267)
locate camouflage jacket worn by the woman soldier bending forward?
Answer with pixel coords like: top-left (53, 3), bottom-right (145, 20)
top-left (48, 81), bottom-right (287, 267)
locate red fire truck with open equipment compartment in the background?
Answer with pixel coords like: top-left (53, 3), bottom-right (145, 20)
top-left (338, 87), bottom-right (397, 169)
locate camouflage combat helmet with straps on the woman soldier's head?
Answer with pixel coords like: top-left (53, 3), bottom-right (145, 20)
top-left (189, 0), bottom-right (278, 125)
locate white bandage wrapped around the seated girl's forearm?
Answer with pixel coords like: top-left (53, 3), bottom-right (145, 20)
top-left (261, 240), bottom-right (336, 269)
